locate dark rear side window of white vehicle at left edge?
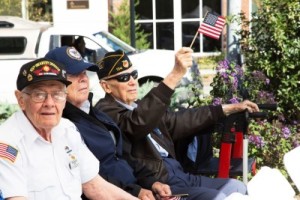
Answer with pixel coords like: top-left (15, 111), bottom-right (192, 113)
top-left (0, 37), bottom-right (27, 54)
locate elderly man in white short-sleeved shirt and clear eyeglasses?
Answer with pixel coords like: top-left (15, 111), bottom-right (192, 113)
top-left (0, 58), bottom-right (137, 200)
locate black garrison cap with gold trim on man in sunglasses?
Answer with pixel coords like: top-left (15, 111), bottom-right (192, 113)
top-left (97, 50), bottom-right (132, 79)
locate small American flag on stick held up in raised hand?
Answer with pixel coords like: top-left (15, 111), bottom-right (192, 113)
top-left (198, 12), bottom-right (225, 40)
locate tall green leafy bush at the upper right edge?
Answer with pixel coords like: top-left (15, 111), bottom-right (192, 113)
top-left (237, 0), bottom-right (300, 123)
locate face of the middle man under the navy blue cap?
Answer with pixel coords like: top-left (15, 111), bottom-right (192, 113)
top-left (67, 71), bottom-right (89, 107)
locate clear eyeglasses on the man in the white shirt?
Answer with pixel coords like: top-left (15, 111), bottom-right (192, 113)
top-left (23, 91), bottom-right (67, 103)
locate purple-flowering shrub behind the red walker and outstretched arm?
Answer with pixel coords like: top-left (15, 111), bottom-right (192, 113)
top-left (211, 60), bottom-right (300, 177)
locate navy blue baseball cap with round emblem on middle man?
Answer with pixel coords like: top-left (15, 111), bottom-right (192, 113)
top-left (45, 46), bottom-right (98, 74)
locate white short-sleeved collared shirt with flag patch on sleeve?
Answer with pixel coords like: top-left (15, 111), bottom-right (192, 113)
top-left (0, 111), bottom-right (99, 200)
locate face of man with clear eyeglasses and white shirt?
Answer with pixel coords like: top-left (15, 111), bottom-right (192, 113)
top-left (15, 81), bottom-right (66, 132)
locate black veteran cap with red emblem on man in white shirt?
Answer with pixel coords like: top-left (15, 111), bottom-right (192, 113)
top-left (17, 58), bottom-right (71, 90)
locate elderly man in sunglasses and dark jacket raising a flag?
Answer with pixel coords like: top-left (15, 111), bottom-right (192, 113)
top-left (96, 47), bottom-right (258, 200)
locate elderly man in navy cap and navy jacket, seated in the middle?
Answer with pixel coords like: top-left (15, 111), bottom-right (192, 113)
top-left (46, 47), bottom-right (171, 200)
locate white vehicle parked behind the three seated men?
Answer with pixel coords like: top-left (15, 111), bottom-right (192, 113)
top-left (0, 16), bottom-right (198, 103)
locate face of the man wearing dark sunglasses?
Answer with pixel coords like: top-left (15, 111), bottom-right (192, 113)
top-left (100, 67), bottom-right (138, 105)
